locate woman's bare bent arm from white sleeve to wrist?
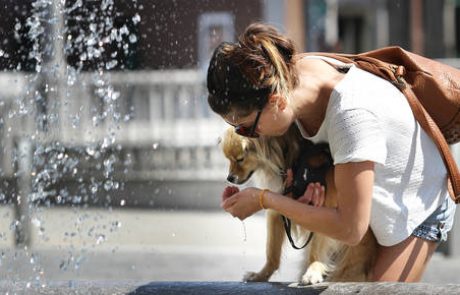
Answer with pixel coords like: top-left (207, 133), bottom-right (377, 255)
top-left (264, 162), bottom-right (374, 245)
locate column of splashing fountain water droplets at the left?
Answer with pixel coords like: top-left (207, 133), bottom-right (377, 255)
top-left (0, 0), bottom-right (141, 286)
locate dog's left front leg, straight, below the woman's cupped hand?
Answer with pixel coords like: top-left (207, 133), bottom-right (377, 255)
top-left (243, 210), bottom-right (284, 282)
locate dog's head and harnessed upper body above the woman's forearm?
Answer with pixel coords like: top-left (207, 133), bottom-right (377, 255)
top-left (221, 125), bottom-right (332, 197)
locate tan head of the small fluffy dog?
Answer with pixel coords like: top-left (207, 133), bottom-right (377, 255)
top-left (220, 128), bottom-right (260, 184)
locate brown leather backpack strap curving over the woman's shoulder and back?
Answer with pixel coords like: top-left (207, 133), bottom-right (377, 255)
top-left (299, 52), bottom-right (460, 204)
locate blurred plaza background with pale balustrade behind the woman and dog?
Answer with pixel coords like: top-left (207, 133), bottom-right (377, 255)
top-left (0, 0), bottom-right (460, 285)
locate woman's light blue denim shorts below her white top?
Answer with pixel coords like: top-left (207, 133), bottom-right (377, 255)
top-left (412, 197), bottom-right (456, 243)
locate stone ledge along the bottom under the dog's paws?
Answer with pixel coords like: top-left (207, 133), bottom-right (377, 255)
top-left (0, 281), bottom-right (460, 295)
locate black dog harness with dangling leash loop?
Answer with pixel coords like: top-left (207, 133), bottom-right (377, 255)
top-left (281, 141), bottom-right (334, 250)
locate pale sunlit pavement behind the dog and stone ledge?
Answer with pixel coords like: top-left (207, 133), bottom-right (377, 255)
top-left (0, 207), bottom-right (460, 294)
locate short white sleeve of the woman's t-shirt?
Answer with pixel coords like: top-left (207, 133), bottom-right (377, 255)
top-left (327, 109), bottom-right (387, 165)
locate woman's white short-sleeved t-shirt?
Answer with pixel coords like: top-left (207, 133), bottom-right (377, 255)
top-left (296, 58), bottom-right (448, 246)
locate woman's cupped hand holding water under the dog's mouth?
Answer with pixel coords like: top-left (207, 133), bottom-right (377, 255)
top-left (221, 187), bottom-right (262, 220)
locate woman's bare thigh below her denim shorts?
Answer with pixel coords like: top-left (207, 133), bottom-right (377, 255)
top-left (372, 236), bottom-right (438, 282)
